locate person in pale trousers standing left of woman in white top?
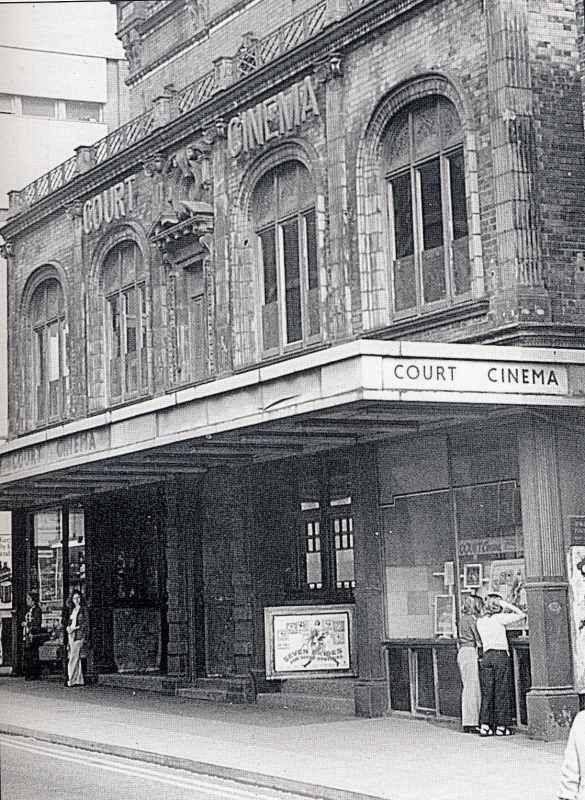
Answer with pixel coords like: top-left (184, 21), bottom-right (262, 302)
top-left (457, 594), bottom-right (483, 733)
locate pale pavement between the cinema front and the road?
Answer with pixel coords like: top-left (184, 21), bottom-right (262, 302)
top-left (0, 678), bottom-right (564, 800)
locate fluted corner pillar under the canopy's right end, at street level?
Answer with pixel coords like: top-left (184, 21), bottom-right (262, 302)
top-left (518, 418), bottom-right (579, 739)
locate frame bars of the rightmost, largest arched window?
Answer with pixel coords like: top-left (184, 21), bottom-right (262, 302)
top-left (384, 101), bottom-right (473, 319)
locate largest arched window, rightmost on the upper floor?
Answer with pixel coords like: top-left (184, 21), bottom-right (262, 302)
top-left (383, 95), bottom-right (471, 315)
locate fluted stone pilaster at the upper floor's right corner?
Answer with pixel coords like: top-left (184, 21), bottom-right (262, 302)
top-left (485, 0), bottom-right (550, 323)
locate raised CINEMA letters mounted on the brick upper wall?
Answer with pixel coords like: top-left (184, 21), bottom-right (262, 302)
top-left (227, 76), bottom-right (321, 158)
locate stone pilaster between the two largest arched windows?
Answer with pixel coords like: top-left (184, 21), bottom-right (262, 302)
top-left (315, 53), bottom-right (351, 340)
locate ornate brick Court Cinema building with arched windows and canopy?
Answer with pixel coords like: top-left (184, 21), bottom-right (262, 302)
top-left (0, 0), bottom-right (585, 738)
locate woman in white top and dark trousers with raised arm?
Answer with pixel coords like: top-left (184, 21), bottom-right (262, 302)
top-left (477, 594), bottom-right (526, 736)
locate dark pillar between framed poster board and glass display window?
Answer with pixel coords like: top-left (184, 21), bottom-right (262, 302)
top-left (352, 445), bottom-right (387, 717)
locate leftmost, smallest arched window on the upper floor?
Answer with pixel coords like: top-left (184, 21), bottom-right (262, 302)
top-left (30, 278), bottom-right (69, 424)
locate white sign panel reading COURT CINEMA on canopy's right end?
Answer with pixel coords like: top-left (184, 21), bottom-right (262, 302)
top-left (384, 358), bottom-right (568, 395)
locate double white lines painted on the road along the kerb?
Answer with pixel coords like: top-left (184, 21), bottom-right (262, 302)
top-left (0, 736), bottom-right (318, 800)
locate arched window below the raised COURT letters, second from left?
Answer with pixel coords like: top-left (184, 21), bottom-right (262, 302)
top-left (102, 241), bottom-right (148, 402)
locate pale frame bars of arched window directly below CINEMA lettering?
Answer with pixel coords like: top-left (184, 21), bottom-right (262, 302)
top-left (251, 158), bottom-right (322, 356)
